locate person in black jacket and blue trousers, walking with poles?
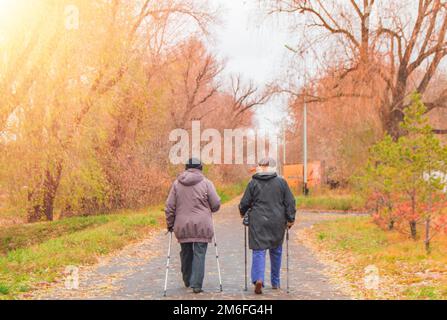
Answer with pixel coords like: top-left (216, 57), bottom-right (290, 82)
top-left (239, 158), bottom-right (296, 294)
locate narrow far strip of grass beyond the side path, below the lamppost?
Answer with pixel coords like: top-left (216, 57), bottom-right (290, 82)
top-left (296, 194), bottom-right (364, 211)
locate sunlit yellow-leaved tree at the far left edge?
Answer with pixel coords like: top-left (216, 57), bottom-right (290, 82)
top-left (0, 0), bottom-right (217, 221)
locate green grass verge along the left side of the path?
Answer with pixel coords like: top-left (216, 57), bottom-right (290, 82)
top-left (0, 210), bottom-right (162, 299)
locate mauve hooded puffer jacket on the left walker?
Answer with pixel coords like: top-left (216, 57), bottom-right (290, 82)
top-left (165, 169), bottom-right (220, 243)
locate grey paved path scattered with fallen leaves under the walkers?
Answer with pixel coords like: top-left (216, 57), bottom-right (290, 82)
top-left (40, 201), bottom-right (349, 300)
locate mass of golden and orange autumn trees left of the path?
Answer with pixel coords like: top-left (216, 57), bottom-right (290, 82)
top-left (0, 0), bottom-right (266, 222)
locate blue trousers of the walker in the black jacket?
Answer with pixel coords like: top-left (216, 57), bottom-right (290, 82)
top-left (251, 246), bottom-right (282, 288)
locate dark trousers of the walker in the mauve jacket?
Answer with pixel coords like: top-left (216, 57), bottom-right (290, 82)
top-left (180, 242), bottom-right (208, 289)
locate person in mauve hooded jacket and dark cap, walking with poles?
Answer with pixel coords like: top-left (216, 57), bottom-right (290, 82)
top-left (165, 158), bottom-right (220, 293)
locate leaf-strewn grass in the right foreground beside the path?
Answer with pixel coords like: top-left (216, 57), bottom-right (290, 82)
top-left (305, 217), bottom-right (447, 300)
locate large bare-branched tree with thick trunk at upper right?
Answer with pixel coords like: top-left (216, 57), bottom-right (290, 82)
top-left (262, 0), bottom-right (447, 139)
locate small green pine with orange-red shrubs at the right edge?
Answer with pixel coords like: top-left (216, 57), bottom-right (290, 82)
top-left (356, 95), bottom-right (447, 252)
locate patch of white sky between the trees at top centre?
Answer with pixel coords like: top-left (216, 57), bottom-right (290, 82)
top-left (212, 0), bottom-right (291, 129)
